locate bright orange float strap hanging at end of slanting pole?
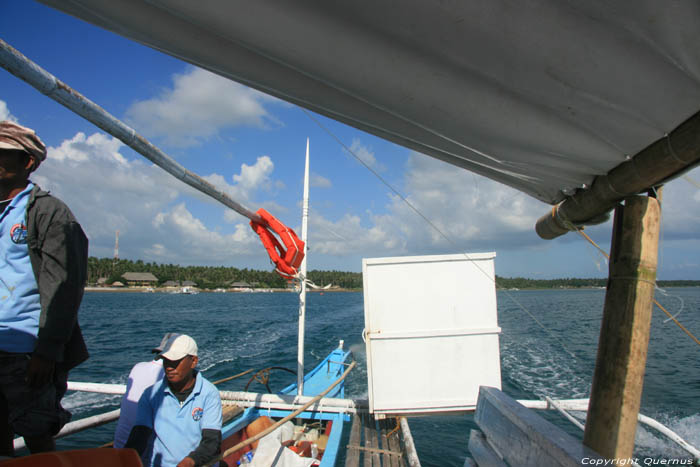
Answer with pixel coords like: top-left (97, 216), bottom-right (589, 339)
top-left (250, 208), bottom-right (304, 280)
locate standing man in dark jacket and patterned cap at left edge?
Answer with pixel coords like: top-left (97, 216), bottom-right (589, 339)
top-left (0, 121), bottom-right (88, 456)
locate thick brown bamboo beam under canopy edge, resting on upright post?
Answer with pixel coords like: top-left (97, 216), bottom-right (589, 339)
top-left (535, 112), bottom-right (700, 240)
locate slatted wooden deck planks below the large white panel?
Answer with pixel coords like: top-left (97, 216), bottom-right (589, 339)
top-left (345, 414), bottom-right (407, 467)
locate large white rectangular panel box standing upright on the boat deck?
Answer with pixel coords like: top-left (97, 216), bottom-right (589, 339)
top-left (362, 253), bottom-right (501, 416)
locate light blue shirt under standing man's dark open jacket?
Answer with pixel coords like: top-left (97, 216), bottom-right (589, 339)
top-left (0, 182), bottom-right (41, 353)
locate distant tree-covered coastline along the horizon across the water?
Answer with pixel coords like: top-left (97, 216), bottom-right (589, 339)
top-left (88, 257), bottom-right (700, 290)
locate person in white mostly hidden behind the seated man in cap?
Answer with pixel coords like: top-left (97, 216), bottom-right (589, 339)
top-left (114, 332), bottom-right (179, 448)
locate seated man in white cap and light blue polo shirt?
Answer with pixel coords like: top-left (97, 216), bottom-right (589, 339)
top-left (125, 334), bottom-right (221, 467)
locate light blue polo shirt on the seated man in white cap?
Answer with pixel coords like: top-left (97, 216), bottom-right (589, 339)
top-left (134, 372), bottom-right (221, 467)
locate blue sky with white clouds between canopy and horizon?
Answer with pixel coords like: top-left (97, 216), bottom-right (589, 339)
top-left (0, 0), bottom-right (700, 280)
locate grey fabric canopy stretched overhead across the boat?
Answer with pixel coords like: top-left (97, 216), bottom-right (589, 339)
top-left (41, 0), bottom-right (700, 204)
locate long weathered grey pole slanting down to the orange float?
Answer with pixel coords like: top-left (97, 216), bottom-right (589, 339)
top-left (0, 39), bottom-right (267, 225)
